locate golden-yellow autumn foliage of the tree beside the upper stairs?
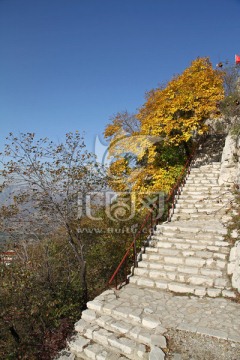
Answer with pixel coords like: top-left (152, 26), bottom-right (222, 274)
top-left (105, 58), bottom-right (224, 193)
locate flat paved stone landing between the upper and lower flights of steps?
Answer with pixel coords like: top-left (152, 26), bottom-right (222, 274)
top-left (88, 284), bottom-right (240, 345)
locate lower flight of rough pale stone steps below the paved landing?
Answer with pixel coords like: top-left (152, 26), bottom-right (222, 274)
top-left (72, 298), bottom-right (167, 360)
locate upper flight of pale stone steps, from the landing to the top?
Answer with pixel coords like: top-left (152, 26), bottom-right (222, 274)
top-left (130, 163), bottom-right (234, 297)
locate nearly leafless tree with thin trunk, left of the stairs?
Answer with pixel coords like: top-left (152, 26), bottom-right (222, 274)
top-left (0, 132), bottom-right (105, 303)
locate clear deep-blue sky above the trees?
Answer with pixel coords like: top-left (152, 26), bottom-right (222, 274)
top-left (0, 0), bottom-right (240, 151)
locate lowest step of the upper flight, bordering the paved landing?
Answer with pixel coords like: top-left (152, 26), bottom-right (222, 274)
top-left (130, 275), bottom-right (235, 298)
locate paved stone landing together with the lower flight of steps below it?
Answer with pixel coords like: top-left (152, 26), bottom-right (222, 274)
top-left (60, 284), bottom-right (240, 360)
